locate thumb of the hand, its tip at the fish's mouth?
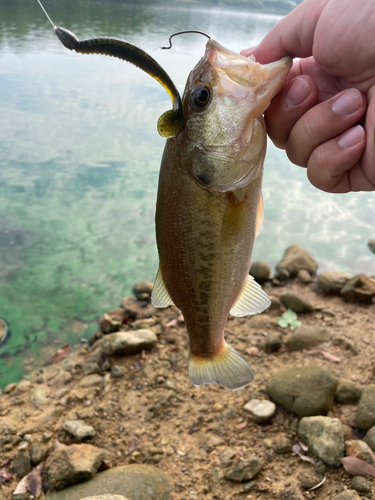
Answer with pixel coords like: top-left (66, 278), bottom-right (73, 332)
top-left (241, 0), bottom-right (328, 64)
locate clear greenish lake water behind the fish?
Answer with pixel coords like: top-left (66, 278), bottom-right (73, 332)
top-left (0, 0), bottom-right (375, 386)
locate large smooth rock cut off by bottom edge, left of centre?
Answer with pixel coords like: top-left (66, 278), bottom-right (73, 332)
top-left (46, 464), bottom-right (172, 500)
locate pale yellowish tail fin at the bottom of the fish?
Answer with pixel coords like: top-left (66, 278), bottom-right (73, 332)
top-left (189, 343), bottom-right (254, 391)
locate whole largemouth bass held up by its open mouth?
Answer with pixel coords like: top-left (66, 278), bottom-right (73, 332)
top-left (151, 39), bottom-right (291, 390)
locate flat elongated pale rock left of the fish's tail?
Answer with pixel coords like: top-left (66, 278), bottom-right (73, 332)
top-left (101, 329), bottom-right (158, 356)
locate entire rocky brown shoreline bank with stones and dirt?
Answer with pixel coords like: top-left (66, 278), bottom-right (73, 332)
top-left (0, 245), bottom-right (375, 500)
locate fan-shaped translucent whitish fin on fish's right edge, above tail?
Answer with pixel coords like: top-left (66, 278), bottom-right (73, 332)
top-left (230, 274), bottom-right (271, 317)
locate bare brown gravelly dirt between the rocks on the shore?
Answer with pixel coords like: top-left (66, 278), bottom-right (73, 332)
top-left (0, 280), bottom-right (375, 500)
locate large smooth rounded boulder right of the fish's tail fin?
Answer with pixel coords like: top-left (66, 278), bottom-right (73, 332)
top-left (267, 365), bottom-right (337, 417)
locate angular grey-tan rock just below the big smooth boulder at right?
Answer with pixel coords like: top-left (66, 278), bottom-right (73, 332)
top-left (298, 416), bottom-right (345, 467)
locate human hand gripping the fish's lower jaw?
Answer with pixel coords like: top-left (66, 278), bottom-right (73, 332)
top-left (242, 0), bottom-right (375, 193)
